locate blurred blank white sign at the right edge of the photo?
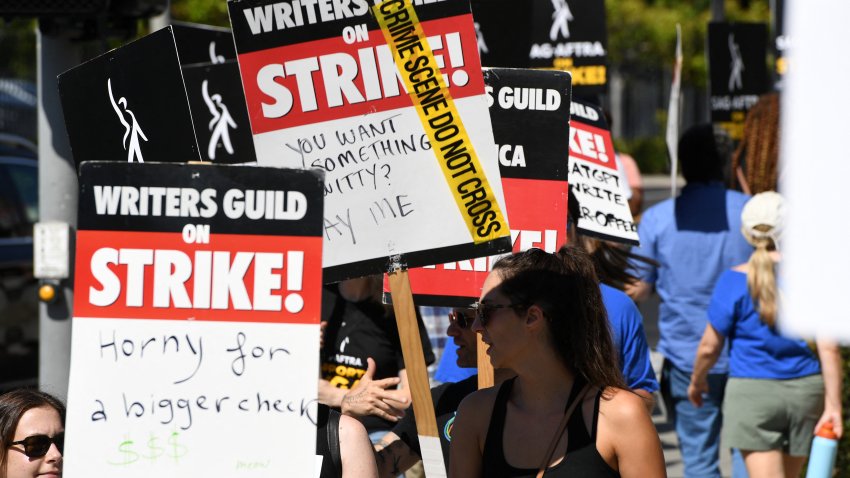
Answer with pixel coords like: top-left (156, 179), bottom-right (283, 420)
top-left (779, 1), bottom-right (850, 344)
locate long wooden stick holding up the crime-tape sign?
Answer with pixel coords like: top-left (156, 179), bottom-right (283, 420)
top-left (389, 269), bottom-right (446, 478)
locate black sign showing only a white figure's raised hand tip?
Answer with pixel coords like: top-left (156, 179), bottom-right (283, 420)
top-left (171, 22), bottom-right (236, 65)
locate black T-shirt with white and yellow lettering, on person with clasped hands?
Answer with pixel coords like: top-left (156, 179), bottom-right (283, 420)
top-left (321, 285), bottom-right (434, 433)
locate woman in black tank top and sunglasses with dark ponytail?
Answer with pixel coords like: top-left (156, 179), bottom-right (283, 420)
top-left (449, 246), bottom-right (666, 478)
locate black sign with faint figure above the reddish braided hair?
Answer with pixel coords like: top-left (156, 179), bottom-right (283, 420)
top-left (708, 22), bottom-right (768, 129)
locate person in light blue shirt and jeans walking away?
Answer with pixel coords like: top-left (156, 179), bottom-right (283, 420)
top-left (626, 124), bottom-right (753, 478)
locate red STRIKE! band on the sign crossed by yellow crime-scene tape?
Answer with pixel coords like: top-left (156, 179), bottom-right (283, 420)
top-left (239, 15), bottom-right (484, 134)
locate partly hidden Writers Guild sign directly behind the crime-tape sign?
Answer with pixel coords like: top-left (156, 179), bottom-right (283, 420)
top-left (400, 68), bottom-right (570, 307)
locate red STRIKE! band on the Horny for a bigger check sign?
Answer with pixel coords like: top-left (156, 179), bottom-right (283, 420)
top-left (74, 230), bottom-right (322, 324)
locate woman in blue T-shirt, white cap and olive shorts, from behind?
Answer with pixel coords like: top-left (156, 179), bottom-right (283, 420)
top-left (688, 192), bottom-right (843, 476)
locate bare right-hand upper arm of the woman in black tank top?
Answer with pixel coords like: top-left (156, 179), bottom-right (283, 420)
top-left (597, 390), bottom-right (667, 478)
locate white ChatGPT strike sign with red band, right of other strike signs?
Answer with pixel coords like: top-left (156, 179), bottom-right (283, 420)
top-left (569, 101), bottom-right (638, 244)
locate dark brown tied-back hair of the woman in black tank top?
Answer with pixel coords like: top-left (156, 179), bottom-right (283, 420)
top-left (493, 246), bottom-right (627, 390)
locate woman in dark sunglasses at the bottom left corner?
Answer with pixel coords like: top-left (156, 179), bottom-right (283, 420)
top-left (0, 389), bottom-right (65, 478)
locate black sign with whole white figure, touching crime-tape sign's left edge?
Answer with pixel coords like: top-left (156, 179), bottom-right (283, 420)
top-left (183, 60), bottom-right (257, 164)
